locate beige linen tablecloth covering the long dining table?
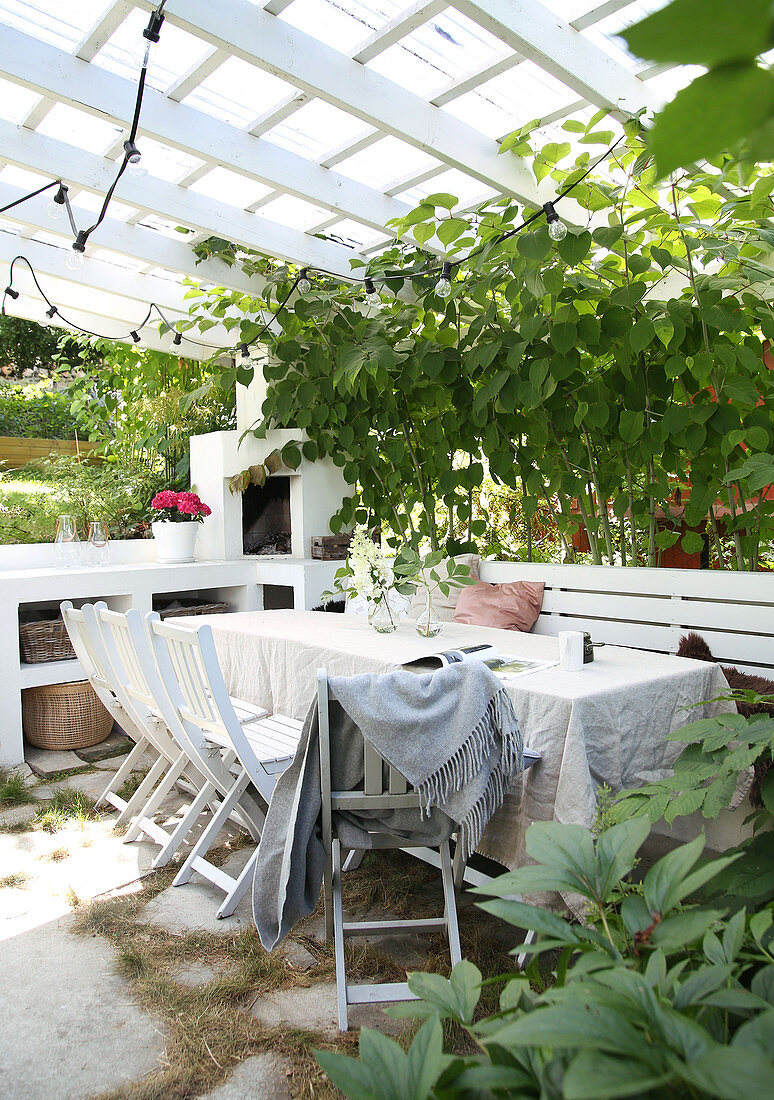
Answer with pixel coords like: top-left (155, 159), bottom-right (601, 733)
top-left (190, 611), bottom-right (734, 869)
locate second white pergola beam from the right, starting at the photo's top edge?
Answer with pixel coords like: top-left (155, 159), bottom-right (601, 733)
top-left (156, 0), bottom-right (538, 202)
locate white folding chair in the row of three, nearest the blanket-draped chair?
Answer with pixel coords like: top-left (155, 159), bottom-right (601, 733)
top-left (146, 615), bottom-right (301, 917)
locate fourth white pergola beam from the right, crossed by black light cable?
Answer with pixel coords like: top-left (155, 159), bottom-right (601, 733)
top-left (0, 121), bottom-right (357, 276)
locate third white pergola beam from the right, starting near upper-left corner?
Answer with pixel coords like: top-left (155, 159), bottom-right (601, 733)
top-left (0, 28), bottom-right (408, 235)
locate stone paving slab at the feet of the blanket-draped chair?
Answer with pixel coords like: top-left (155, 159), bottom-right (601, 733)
top-left (250, 981), bottom-right (406, 1036)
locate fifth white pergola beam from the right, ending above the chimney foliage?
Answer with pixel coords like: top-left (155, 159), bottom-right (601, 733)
top-left (0, 184), bottom-right (263, 294)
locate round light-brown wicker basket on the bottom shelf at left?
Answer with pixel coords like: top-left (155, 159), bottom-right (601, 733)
top-left (22, 680), bottom-right (113, 749)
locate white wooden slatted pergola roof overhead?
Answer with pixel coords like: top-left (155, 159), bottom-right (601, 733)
top-left (0, 0), bottom-right (688, 354)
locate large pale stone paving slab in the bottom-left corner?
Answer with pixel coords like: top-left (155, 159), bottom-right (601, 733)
top-left (0, 917), bottom-right (164, 1100)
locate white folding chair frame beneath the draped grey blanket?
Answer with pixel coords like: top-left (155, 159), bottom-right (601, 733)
top-left (317, 669), bottom-right (462, 1031)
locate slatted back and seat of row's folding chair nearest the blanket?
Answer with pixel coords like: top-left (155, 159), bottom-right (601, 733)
top-left (147, 615), bottom-right (288, 803)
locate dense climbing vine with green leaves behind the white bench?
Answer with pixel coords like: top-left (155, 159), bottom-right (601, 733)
top-left (182, 111), bottom-right (774, 570)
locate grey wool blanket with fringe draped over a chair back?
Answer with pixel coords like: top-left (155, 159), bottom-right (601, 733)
top-left (253, 661), bottom-right (523, 950)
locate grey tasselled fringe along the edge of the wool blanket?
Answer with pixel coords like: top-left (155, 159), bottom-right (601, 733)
top-left (418, 688), bottom-right (523, 859)
